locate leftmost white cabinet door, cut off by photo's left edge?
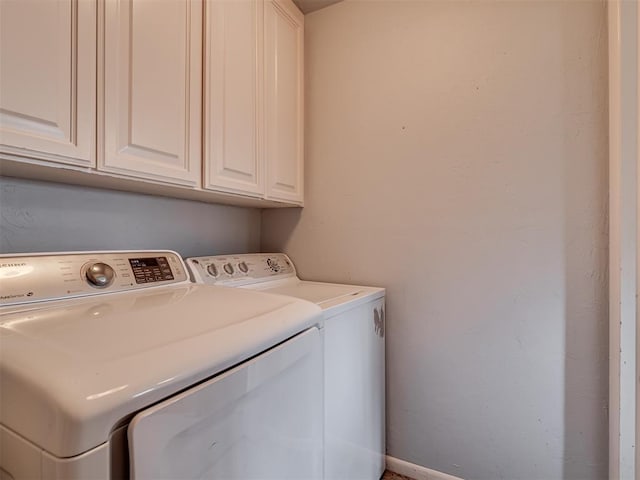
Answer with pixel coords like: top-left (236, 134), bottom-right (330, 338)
top-left (0, 0), bottom-right (96, 166)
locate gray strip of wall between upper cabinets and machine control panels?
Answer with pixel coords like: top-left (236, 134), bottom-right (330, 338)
top-left (0, 177), bottom-right (260, 256)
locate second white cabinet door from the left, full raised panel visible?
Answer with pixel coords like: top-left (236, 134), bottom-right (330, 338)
top-left (98, 0), bottom-right (202, 186)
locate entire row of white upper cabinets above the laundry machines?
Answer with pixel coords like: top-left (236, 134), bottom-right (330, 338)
top-left (0, 0), bottom-right (303, 207)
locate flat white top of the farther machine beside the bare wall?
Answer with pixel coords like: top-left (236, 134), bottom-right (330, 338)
top-left (260, 280), bottom-right (385, 318)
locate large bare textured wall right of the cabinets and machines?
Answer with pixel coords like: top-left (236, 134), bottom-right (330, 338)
top-left (262, 0), bottom-right (607, 480)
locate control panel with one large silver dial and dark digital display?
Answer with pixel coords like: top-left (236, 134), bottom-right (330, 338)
top-left (0, 251), bottom-right (189, 306)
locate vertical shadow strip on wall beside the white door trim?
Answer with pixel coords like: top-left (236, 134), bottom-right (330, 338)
top-left (563, 2), bottom-right (609, 479)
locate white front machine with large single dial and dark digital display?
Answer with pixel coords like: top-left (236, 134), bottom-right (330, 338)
top-left (0, 251), bottom-right (323, 480)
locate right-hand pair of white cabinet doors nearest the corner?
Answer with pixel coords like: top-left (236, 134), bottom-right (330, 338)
top-left (204, 0), bottom-right (304, 204)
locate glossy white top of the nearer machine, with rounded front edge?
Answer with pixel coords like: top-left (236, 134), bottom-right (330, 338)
top-left (0, 284), bottom-right (320, 457)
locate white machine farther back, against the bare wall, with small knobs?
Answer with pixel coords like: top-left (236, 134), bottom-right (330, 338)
top-left (187, 254), bottom-right (385, 480)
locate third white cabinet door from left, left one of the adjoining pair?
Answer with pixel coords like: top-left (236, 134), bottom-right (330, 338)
top-left (204, 0), bottom-right (264, 196)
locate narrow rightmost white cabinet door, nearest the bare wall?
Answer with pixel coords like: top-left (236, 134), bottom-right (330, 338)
top-left (264, 0), bottom-right (304, 203)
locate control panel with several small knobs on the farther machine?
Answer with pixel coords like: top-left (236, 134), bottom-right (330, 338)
top-left (186, 253), bottom-right (296, 285)
